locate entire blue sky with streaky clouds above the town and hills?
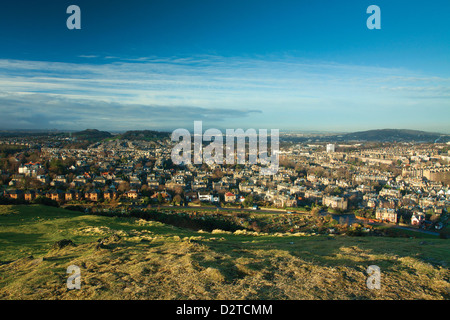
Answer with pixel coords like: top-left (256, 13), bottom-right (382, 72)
top-left (0, 0), bottom-right (450, 133)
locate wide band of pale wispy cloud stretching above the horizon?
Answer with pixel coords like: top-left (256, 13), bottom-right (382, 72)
top-left (0, 55), bottom-right (450, 129)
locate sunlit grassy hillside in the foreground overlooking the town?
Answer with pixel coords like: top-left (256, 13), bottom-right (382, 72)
top-left (0, 206), bottom-right (450, 299)
